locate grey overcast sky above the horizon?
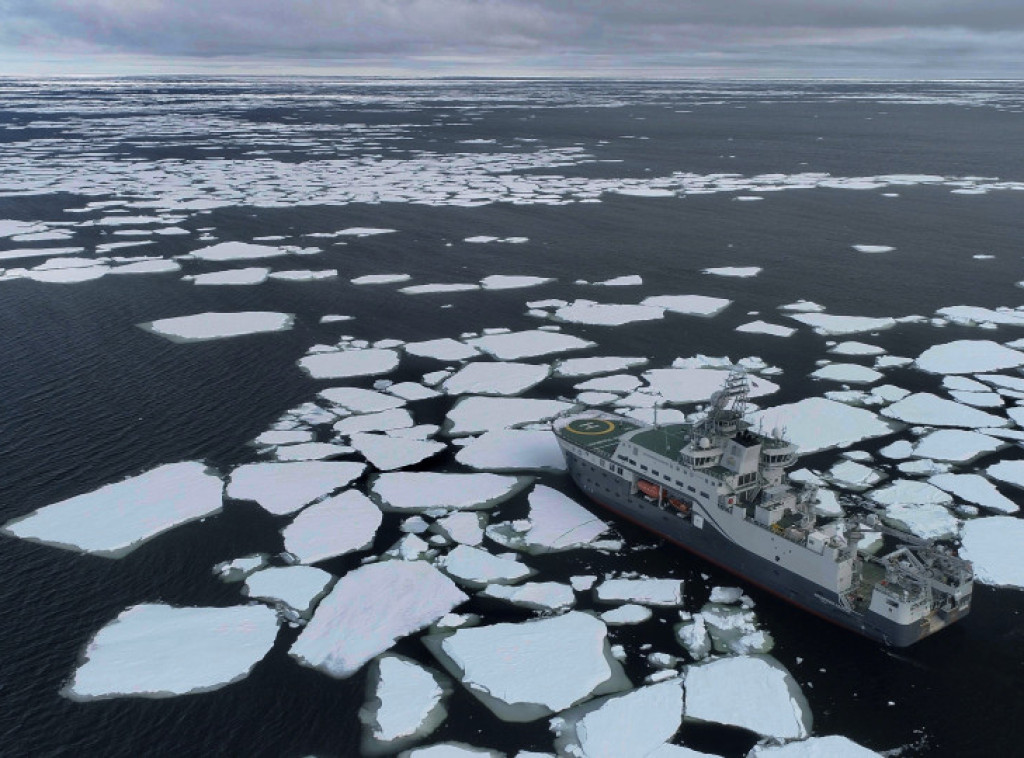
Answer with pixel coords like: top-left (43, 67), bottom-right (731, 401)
top-left (0, 0), bottom-right (1024, 79)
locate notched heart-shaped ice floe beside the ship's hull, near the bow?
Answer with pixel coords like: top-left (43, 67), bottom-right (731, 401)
top-left (486, 485), bottom-right (608, 554)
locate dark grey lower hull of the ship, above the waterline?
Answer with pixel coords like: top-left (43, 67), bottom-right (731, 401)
top-left (566, 453), bottom-right (957, 647)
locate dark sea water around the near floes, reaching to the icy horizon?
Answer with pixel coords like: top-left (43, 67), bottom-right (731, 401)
top-left (0, 79), bottom-right (1024, 756)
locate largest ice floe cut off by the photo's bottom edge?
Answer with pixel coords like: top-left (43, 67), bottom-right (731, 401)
top-left (551, 676), bottom-right (683, 758)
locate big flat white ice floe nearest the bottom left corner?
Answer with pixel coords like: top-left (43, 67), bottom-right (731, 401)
top-left (62, 603), bottom-right (278, 701)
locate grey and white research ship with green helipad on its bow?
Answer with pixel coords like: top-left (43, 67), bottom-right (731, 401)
top-left (553, 369), bottom-right (974, 647)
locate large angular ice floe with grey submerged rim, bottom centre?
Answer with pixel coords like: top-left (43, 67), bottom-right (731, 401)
top-left (424, 610), bottom-right (629, 721)
